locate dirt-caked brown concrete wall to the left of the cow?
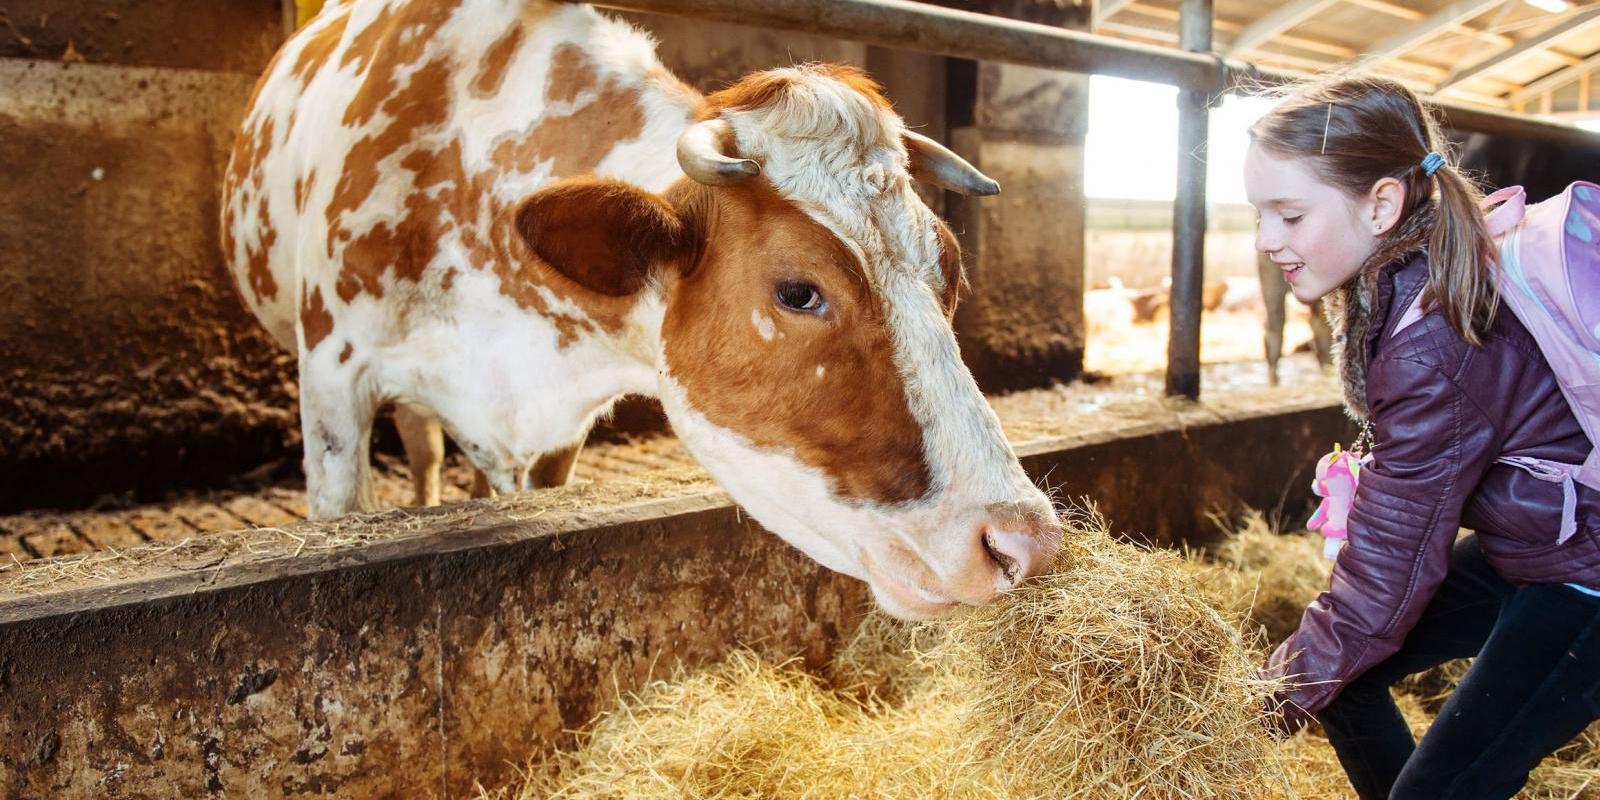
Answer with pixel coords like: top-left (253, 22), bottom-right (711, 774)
top-left (0, 59), bottom-right (296, 510)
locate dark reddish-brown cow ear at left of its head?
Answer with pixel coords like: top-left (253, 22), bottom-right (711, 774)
top-left (517, 178), bottom-right (691, 298)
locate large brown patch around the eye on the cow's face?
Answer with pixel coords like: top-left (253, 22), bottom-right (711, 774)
top-left (662, 179), bottom-right (933, 502)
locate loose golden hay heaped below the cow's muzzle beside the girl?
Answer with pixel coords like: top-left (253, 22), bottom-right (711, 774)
top-left (482, 517), bottom-right (1600, 800)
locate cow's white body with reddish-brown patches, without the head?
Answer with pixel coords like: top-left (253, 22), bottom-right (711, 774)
top-left (224, 2), bottom-right (698, 514)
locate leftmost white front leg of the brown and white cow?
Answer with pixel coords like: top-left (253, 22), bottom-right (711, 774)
top-left (301, 368), bottom-right (378, 518)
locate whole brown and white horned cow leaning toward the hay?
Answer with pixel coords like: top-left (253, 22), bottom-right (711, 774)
top-left (222, 0), bottom-right (1059, 618)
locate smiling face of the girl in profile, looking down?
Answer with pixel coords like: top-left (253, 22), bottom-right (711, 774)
top-left (1245, 144), bottom-right (1392, 302)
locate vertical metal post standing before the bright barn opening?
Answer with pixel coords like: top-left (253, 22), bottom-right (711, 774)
top-left (1166, 0), bottom-right (1213, 400)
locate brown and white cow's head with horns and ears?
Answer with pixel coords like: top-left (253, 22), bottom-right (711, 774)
top-left (518, 67), bottom-right (1059, 618)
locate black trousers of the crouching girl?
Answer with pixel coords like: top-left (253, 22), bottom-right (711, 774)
top-left (1317, 536), bottom-right (1600, 800)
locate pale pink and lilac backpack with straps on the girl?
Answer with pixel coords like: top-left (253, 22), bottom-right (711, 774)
top-left (1395, 181), bottom-right (1600, 542)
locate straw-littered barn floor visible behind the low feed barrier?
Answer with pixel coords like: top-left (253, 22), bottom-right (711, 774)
top-left (0, 354), bottom-right (1331, 562)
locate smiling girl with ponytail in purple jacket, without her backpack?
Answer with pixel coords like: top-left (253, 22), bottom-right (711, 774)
top-left (1245, 77), bottom-right (1600, 798)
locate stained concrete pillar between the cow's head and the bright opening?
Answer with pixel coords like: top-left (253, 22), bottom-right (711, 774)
top-left (942, 0), bottom-right (1090, 390)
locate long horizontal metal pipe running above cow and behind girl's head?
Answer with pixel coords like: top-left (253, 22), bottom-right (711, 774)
top-left (598, 0), bottom-right (1600, 147)
